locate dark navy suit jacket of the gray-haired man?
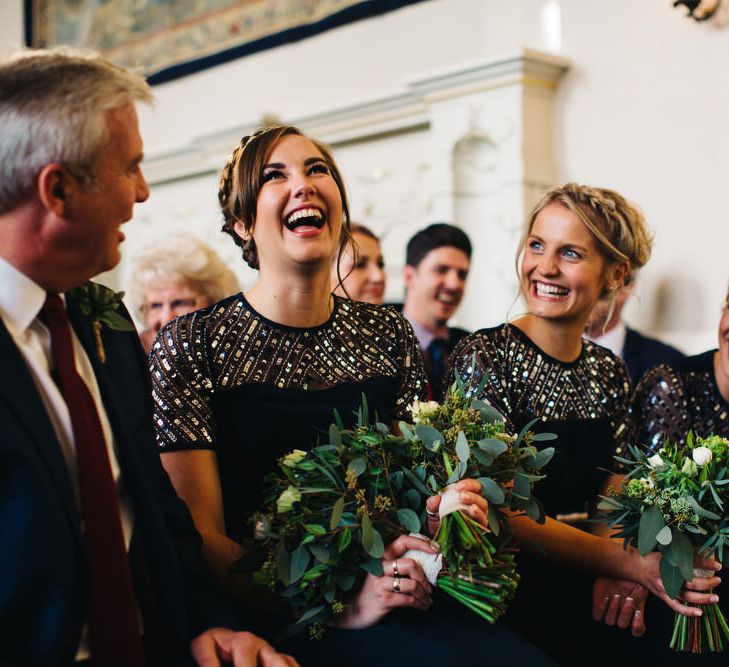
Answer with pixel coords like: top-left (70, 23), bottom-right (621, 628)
top-left (0, 292), bottom-right (235, 667)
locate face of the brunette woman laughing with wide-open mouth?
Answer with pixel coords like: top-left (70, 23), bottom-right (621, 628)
top-left (235, 135), bottom-right (342, 270)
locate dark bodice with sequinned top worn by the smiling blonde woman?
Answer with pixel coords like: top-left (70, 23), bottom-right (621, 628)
top-left (448, 324), bottom-right (630, 515)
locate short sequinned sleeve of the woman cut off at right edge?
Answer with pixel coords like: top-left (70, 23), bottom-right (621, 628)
top-left (632, 364), bottom-right (690, 452)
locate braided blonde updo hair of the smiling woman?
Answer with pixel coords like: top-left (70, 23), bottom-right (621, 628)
top-left (516, 183), bottom-right (653, 297)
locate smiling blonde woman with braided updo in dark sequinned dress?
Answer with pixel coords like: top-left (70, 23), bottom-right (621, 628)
top-left (448, 183), bottom-right (706, 664)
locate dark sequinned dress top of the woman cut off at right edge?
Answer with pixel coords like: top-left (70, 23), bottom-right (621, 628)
top-left (633, 350), bottom-right (729, 451)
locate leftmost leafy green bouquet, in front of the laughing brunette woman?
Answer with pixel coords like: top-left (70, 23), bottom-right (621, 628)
top-left (243, 400), bottom-right (422, 638)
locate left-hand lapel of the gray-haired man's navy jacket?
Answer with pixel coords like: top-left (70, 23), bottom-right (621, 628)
top-left (0, 320), bottom-right (81, 539)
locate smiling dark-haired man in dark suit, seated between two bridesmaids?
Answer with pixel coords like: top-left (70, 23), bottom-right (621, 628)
top-left (402, 223), bottom-right (471, 400)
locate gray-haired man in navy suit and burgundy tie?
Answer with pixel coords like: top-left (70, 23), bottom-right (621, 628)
top-left (0, 51), bottom-right (295, 667)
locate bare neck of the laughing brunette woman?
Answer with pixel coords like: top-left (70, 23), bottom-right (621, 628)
top-left (245, 270), bottom-right (334, 327)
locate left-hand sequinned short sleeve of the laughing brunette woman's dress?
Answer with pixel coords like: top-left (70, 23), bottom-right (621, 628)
top-left (149, 313), bottom-right (215, 451)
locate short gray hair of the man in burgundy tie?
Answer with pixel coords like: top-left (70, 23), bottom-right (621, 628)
top-left (0, 48), bottom-right (152, 213)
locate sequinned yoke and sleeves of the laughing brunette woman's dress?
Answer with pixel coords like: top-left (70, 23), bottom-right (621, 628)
top-left (150, 294), bottom-right (425, 450)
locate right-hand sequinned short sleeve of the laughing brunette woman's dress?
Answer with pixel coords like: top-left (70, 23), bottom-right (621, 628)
top-left (387, 308), bottom-right (427, 421)
